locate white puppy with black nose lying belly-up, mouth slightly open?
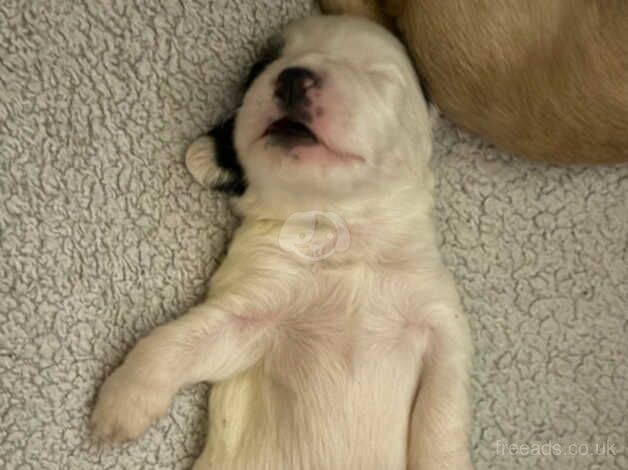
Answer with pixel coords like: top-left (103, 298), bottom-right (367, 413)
top-left (92, 17), bottom-right (472, 470)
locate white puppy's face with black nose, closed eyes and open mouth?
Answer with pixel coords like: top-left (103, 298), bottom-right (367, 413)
top-left (235, 16), bottom-right (430, 203)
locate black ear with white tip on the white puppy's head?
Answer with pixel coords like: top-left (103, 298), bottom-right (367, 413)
top-left (185, 54), bottom-right (275, 196)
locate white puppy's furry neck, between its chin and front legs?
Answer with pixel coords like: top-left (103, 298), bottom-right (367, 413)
top-left (235, 185), bottom-right (439, 265)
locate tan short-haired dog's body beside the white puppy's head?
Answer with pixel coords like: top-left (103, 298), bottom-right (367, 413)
top-left (321, 0), bottom-right (628, 164)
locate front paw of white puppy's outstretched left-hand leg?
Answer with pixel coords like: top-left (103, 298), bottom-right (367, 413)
top-left (90, 366), bottom-right (171, 444)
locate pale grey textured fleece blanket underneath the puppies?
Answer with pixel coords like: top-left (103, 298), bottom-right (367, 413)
top-left (0, 0), bottom-right (628, 470)
